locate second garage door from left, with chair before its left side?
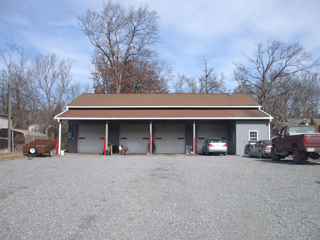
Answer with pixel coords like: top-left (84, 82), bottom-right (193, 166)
top-left (119, 124), bottom-right (150, 153)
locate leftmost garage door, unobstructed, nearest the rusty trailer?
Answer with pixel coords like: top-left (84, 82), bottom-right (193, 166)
top-left (77, 124), bottom-right (106, 153)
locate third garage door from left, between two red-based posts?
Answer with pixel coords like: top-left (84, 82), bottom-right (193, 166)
top-left (154, 124), bottom-right (186, 153)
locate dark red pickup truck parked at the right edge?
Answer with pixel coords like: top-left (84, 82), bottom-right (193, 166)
top-left (271, 125), bottom-right (320, 164)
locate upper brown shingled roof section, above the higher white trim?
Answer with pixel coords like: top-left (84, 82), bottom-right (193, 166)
top-left (68, 93), bottom-right (260, 107)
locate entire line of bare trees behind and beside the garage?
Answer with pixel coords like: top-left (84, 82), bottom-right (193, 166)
top-left (0, 0), bottom-right (320, 137)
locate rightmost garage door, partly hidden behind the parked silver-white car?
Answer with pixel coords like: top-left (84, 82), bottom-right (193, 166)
top-left (197, 124), bottom-right (228, 153)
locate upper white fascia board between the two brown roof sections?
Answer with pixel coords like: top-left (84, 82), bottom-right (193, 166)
top-left (67, 106), bottom-right (261, 109)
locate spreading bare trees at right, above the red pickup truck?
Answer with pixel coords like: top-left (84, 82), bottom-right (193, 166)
top-left (234, 41), bottom-right (320, 122)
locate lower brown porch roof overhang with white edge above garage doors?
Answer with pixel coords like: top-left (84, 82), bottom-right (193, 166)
top-left (55, 108), bottom-right (273, 120)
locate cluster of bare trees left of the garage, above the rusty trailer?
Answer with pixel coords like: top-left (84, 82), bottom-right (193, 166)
top-left (0, 42), bottom-right (82, 137)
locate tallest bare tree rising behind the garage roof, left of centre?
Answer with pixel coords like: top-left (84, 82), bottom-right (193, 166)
top-left (77, 0), bottom-right (159, 93)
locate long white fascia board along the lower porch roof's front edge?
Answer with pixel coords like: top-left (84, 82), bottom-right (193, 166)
top-left (55, 117), bottom-right (270, 120)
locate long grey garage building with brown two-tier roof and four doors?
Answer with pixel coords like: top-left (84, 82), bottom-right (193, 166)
top-left (55, 93), bottom-right (272, 154)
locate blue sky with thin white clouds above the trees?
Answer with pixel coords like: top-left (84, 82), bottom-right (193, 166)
top-left (0, 0), bottom-right (320, 92)
